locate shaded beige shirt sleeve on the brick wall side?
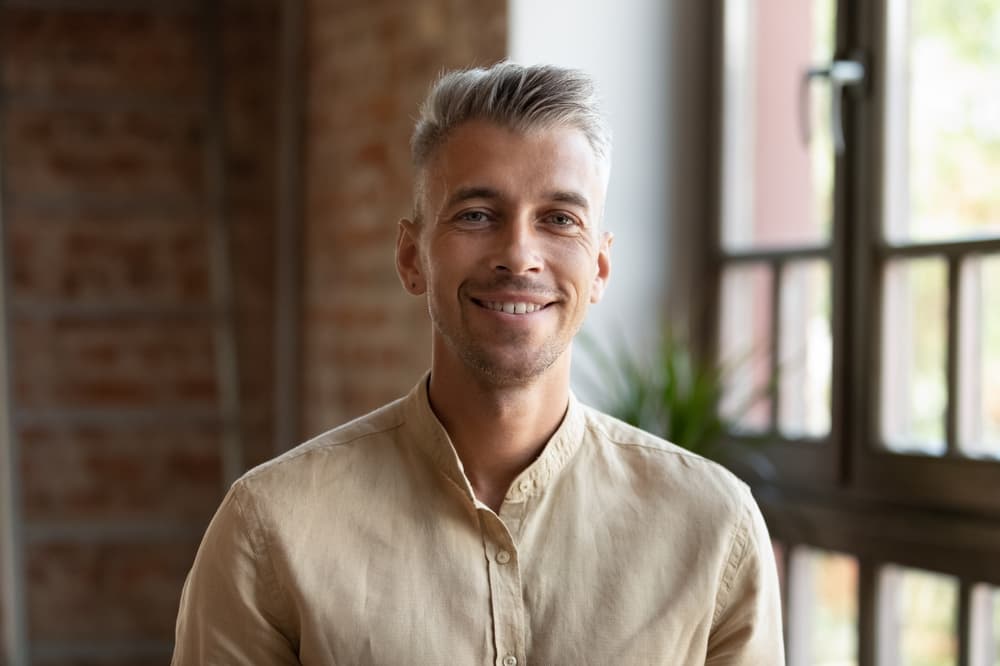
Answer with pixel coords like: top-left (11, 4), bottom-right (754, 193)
top-left (171, 482), bottom-right (299, 666)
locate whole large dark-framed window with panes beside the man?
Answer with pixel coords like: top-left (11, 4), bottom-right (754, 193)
top-left (712, 0), bottom-right (1000, 666)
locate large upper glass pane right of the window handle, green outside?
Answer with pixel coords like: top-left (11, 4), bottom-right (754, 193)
top-left (884, 0), bottom-right (1000, 242)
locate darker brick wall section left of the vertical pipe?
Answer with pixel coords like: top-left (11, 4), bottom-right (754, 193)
top-left (0, 0), bottom-right (278, 664)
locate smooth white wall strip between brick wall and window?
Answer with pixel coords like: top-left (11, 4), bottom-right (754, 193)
top-left (508, 0), bottom-right (675, 399)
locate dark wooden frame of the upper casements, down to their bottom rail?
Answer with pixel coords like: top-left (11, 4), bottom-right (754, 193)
top-left (701, 0), bottom-right (1000, 518)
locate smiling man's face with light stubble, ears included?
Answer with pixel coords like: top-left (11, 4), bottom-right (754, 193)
top-left (397, 121), bottom-right (611, 386)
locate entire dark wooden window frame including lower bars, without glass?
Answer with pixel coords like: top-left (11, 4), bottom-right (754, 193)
top-left (708, 0), bottom-right (1000, 666)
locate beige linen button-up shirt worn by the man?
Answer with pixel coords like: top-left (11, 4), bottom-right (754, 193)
top-left (173, 377), bottom-right (784, 666)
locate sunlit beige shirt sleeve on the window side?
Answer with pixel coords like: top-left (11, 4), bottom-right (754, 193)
top-left (705, 491), bottom-right (785, 666)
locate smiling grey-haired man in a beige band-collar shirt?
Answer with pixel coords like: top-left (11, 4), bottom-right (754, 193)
top-left (174, 63), bottom-right (783, 666)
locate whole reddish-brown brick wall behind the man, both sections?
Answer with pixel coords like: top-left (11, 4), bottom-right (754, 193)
top-left (0, 0), bottom-right (506, 664)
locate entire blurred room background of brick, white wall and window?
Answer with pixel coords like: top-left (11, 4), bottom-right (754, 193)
top-left (0, 0), bottom-right (1000, 666)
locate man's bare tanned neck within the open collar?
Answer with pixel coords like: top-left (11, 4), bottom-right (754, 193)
top-left (428, 350), bottom-right (569, 511)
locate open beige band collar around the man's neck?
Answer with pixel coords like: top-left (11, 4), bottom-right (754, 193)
top-left (404, 371), bottom-right (584, 505)
